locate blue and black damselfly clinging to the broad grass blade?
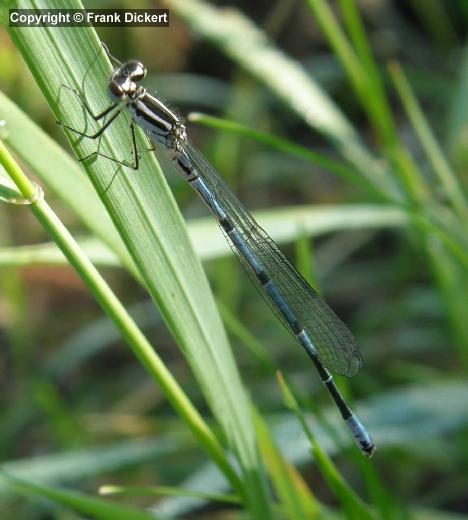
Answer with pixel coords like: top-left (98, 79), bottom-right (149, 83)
top-left (56, 48), bottom-right (374, 456)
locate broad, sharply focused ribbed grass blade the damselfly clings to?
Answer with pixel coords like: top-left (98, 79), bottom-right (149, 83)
top-left (6, 1), bottom-right (269, 518)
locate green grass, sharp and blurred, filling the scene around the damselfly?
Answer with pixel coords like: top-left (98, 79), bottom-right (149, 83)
top-left (0, 0), bottom-right (468, 520)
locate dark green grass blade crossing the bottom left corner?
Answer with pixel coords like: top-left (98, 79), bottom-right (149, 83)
top-left (0, 473), bottom-right (162, 520)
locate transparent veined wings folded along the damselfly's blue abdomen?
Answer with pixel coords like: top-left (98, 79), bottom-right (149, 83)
top-left (182, 140), bottom-right (362, 376)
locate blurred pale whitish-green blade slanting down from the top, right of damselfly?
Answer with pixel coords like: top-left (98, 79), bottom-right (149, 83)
top-left (166, 0), bottom-right (400, 200)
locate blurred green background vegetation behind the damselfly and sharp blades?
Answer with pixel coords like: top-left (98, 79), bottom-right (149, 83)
top-left (0, 0), bottom-right (468, 519)
